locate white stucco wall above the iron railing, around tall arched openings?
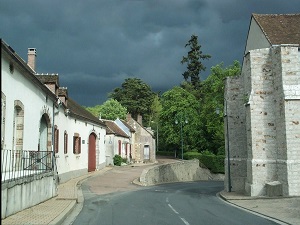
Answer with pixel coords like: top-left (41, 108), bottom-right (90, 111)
top-left (1, 49), bottom-right (53, 150)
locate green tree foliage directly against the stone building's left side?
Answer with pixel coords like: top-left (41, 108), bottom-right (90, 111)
top-left (199, 61), bottom-right (240, 155)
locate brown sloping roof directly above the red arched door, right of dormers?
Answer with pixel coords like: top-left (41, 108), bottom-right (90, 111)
top-left (67, 98), bottom-right (105, 126)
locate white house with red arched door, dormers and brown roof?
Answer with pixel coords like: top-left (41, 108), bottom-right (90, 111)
top-left (36, 74), bottom-right (106, 182)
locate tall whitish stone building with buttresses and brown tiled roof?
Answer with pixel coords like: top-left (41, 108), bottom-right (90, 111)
top-left (224, 14), bottom-right (300, 196)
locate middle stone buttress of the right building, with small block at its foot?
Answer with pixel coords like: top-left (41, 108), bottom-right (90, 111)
top-left (246, 49), bottom-right (277, 196)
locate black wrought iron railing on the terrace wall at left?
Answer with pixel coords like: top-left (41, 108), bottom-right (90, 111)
top-left (1, 149), bottom-right (53, 182)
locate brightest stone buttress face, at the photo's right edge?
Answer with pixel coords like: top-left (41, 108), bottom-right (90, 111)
top-left (274, 45), bottom-right (300, 196)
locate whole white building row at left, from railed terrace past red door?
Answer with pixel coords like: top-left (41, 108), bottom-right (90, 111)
top-left (1, 40), bottom-right (106, 218)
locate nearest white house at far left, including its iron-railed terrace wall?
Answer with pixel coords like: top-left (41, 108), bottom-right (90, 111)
top-left (1, 40), bottom-right (58, 218)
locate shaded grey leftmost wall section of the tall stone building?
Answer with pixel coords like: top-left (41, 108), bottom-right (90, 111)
top-left (224, 76), bottom-right (247, 193)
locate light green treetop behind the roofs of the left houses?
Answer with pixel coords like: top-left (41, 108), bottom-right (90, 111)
top-left (86, 99), bottom-right (127, 120)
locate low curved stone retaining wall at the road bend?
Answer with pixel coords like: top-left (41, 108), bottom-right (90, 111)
top-left (139, 159), bottom-right (224, 186)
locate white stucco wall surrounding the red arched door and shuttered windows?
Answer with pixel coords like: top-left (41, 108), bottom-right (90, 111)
top-left (55, 110), bottom-right (106, 182)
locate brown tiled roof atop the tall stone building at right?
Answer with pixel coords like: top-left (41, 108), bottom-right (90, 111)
top-left (252, 13), bottom-right (300, 45)
